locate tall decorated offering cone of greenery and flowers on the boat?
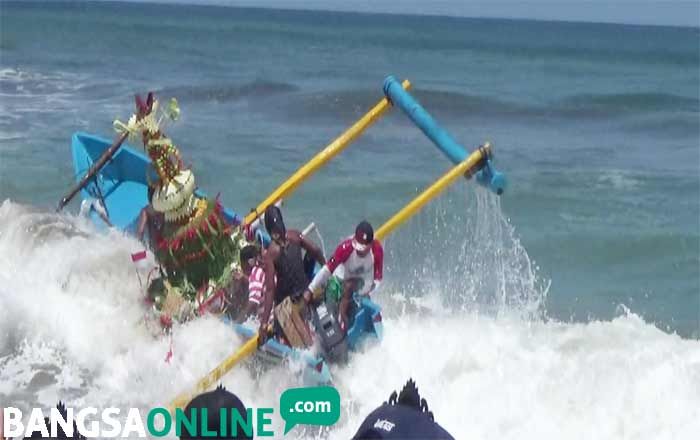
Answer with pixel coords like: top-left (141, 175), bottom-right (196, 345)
top-left (114, 93), bottom-right (247, 320)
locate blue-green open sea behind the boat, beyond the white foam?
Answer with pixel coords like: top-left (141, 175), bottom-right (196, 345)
top-left (0, 3), bottom-right (700, 337)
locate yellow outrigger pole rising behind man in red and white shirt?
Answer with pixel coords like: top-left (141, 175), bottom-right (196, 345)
top-left (374, 142), bottom-right (491, 240)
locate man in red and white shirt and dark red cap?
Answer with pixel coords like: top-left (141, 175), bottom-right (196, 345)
top-left (304, 220), bottom-right (384, 330)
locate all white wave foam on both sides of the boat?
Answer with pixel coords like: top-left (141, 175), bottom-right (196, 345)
top-left (0, 201), bottom-right (700, 440)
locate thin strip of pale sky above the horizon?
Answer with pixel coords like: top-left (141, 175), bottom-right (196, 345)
top-left (124, 0), bottom-right (700, 27)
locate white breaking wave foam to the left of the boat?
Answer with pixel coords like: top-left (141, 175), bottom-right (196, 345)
top-left (0, 201), bottom-right (314, 436)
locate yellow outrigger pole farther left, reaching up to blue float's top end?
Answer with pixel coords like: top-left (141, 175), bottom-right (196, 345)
top-left (243, 80), bottom-right (411, 225)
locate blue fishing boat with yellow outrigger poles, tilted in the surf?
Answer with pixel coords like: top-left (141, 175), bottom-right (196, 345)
top-left (59, 76), bottom-right (506, 412)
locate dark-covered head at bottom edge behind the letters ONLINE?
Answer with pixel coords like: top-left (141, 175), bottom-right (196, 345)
top-left (180, 385), bottom-right (253, 439)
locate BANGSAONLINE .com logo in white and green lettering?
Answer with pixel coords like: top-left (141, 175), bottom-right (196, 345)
top-left (0, 387), bottom-right (340, 438)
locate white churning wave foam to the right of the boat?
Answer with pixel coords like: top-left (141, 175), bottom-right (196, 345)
top-left (330, 312), bottom-right (700, 440)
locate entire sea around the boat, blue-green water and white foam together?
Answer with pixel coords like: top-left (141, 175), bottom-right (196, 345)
top-left (0, 2), bottom-right (700, 439)
